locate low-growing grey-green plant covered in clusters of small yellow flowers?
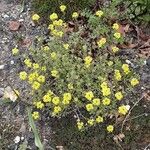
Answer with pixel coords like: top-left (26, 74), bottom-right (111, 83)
top-left (13, 5), bottom-right (139, 132)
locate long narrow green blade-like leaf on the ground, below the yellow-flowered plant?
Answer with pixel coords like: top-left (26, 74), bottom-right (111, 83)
top-left (27, 108), bottom-right (44, 150)
